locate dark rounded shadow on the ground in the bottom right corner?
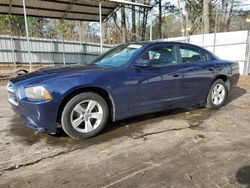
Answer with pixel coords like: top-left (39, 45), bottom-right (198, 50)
top-left (235, 165), bottom-right (250, 188)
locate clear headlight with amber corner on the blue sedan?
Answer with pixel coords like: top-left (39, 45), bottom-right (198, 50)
top-left (24, 86), bottom-right (52, 100)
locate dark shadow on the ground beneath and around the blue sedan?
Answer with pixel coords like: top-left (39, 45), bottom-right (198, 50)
top-left (8, 87), bottom-right (247, 145)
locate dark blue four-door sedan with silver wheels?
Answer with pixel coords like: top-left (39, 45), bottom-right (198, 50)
top-left (7, 42), bottom-right (239, 138)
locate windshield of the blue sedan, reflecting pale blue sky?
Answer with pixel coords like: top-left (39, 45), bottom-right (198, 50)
top-left (92, 44), bottom-right (142, 67)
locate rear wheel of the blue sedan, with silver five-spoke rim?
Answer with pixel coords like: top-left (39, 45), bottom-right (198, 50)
top-left (206, 79), bottom-right (228, 109)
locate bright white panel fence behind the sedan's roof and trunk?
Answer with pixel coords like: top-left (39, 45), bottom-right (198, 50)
top-left (164, 31), bottom-right (250, 74)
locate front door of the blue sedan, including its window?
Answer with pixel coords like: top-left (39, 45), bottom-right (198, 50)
top-left (129, 44), bottom-right (182, 112)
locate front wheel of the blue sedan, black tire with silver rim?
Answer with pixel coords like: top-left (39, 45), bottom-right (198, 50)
top-left (61, 92), bottom-right (109, 138)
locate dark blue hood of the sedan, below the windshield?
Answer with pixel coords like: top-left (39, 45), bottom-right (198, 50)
top-left (10, 65), bottom-right (105, 83)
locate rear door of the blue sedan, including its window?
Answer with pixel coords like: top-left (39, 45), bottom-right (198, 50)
top-left (177, 45), bottom-right (215, 103)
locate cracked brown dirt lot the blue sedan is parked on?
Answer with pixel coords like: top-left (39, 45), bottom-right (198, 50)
top-left (0, 77), bottom-right (250, 188)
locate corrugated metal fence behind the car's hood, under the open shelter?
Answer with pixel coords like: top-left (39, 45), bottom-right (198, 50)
top-left (0, 35), bottom-right (110, 65)
